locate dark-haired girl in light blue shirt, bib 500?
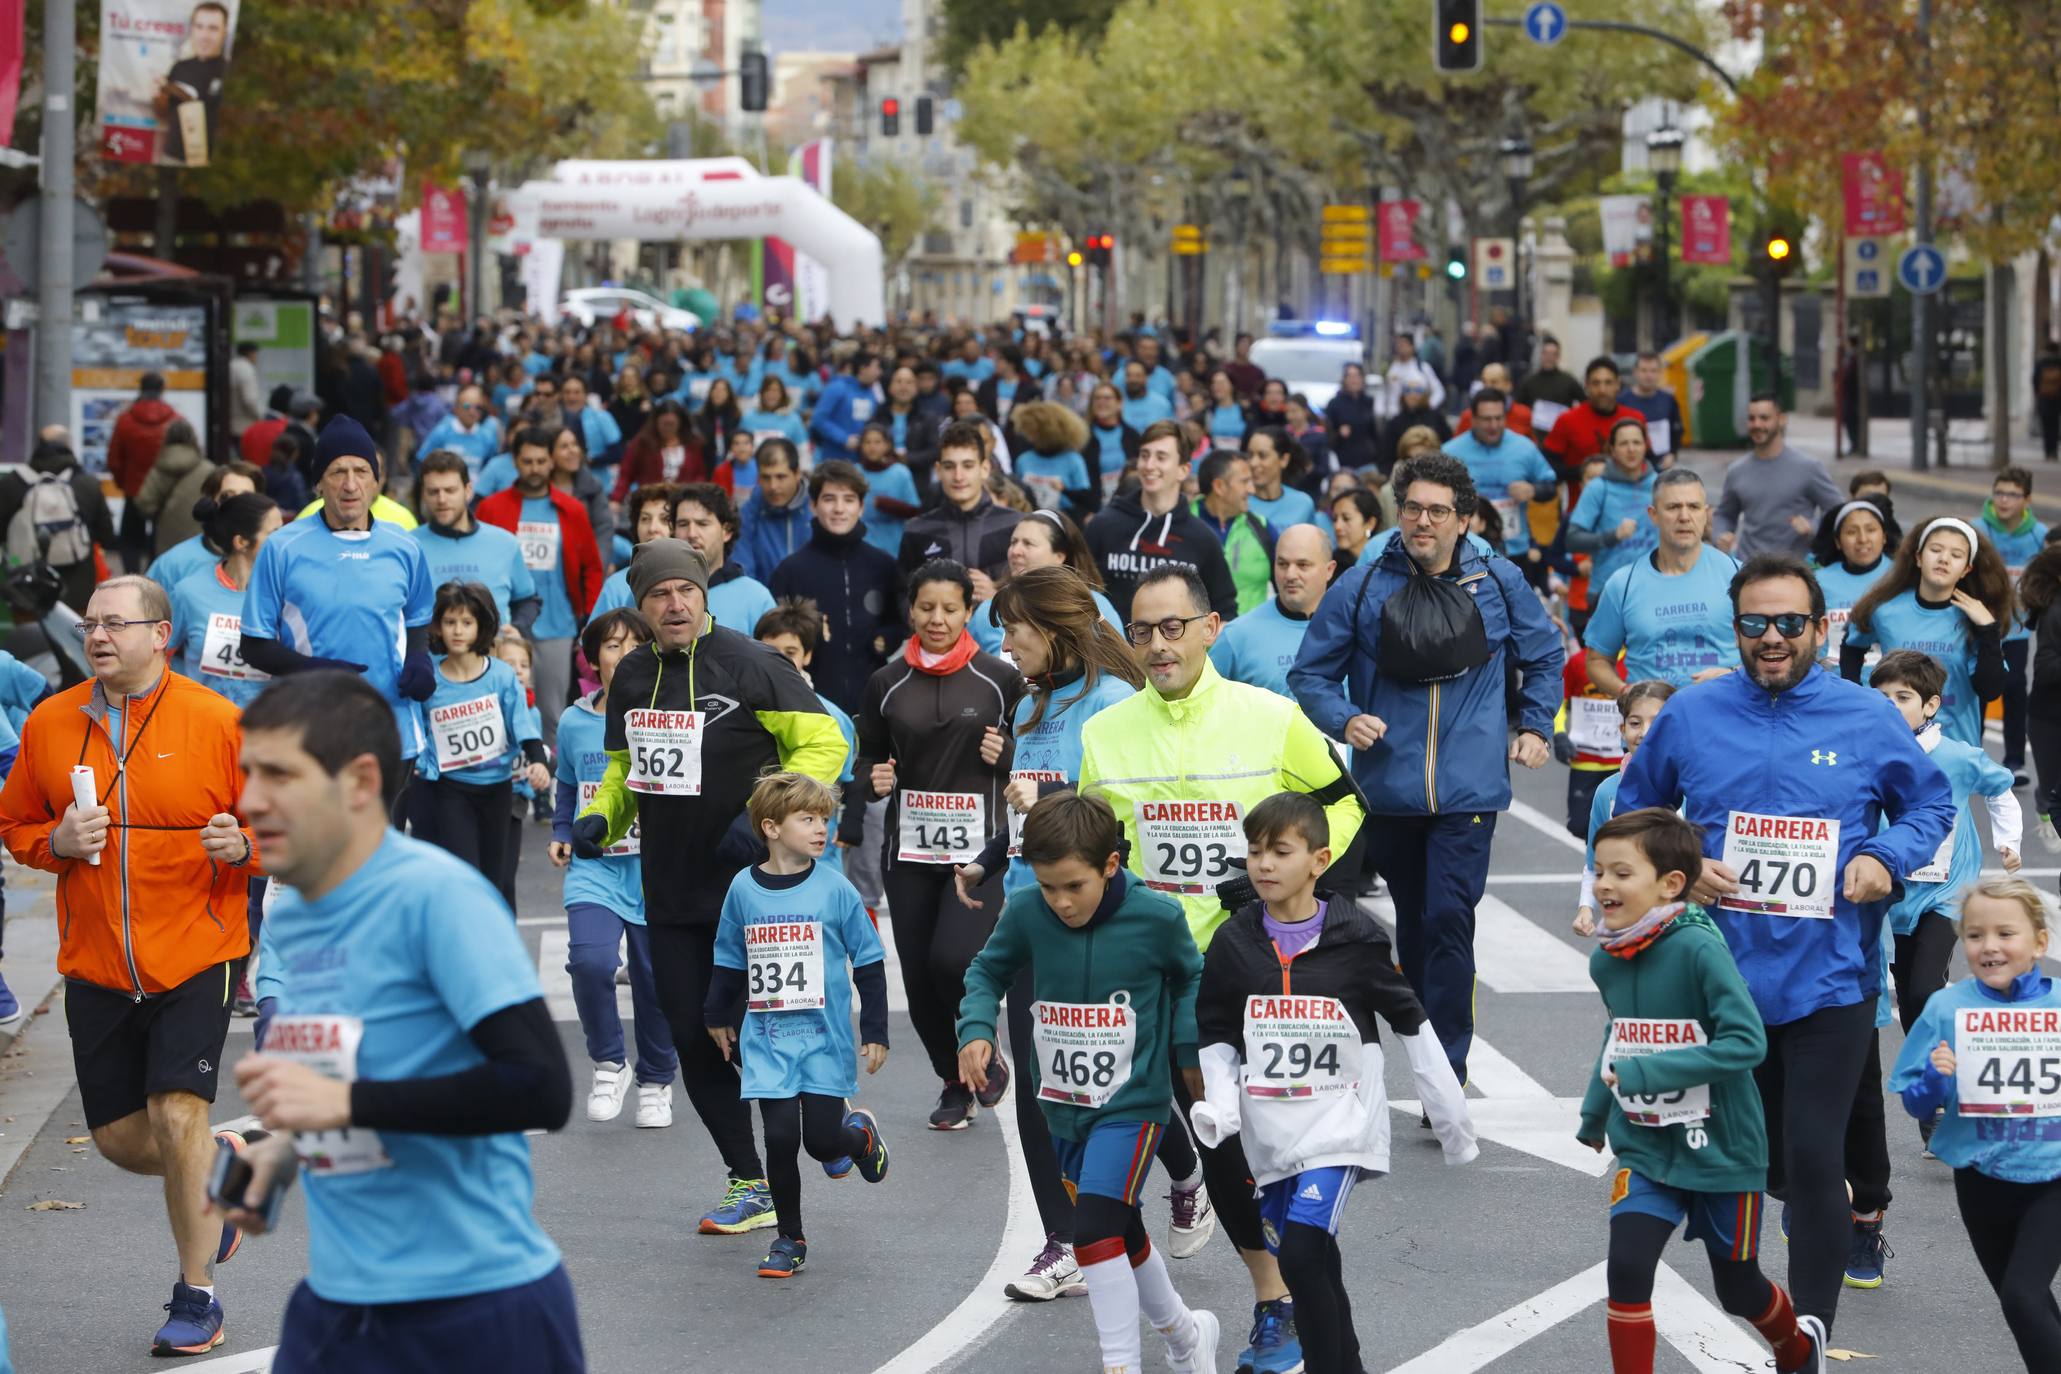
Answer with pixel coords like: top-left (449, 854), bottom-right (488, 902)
top-left (416, 583), bottom-right (550, 911)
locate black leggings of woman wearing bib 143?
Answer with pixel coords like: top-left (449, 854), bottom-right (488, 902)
top-left (886, 863), bottom-right (1002, 1084)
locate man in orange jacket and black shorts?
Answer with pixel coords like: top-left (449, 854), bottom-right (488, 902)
top-left (0, 577), bottom-right (257, 1355)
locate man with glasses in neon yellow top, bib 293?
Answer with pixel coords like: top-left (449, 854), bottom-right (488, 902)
top-left (1080, 562), bottom-right (1364, 1374)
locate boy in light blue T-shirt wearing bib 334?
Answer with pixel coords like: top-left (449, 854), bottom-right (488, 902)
top-left (703, 772), bottom-right (888, 1279)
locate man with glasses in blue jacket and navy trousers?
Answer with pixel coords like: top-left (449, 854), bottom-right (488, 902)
top-left (1288, 453), bottom-right (1566, 1084)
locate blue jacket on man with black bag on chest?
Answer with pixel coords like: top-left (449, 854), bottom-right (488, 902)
top-left (1288, 540), bottom-right (1566, 816)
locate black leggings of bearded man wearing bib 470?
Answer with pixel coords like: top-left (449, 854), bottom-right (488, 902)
top-left (1754, 997), bottom-right (1882, 1331)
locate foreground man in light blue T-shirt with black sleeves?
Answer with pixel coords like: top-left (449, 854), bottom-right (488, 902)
top-left (229, 672), bottom-right (585, 1374)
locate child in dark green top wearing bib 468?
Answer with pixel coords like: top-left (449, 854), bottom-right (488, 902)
top-left (958, 791), bottom-right (1222, 1374)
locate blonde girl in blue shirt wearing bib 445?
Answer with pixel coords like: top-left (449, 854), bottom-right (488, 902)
top-left (1890, 878), bottom-right (2061, 1372)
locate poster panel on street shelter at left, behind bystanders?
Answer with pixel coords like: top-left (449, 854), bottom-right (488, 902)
top-left (72, 301), bottom-right (208, 472)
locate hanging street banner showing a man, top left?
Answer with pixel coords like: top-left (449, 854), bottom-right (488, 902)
top-left (97, 0), bottom-right (241, 167)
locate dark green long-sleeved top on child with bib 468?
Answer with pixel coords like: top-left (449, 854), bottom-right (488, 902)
top-left (958, 869), bottom-right (1202, 1141)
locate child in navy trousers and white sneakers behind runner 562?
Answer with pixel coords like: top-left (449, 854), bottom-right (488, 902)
top-left (550, 608), bottom-right (680, 1129)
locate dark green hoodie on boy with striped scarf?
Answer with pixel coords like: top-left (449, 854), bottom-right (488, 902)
top-left (1579, 906), bottom-right (1768, 1193)
